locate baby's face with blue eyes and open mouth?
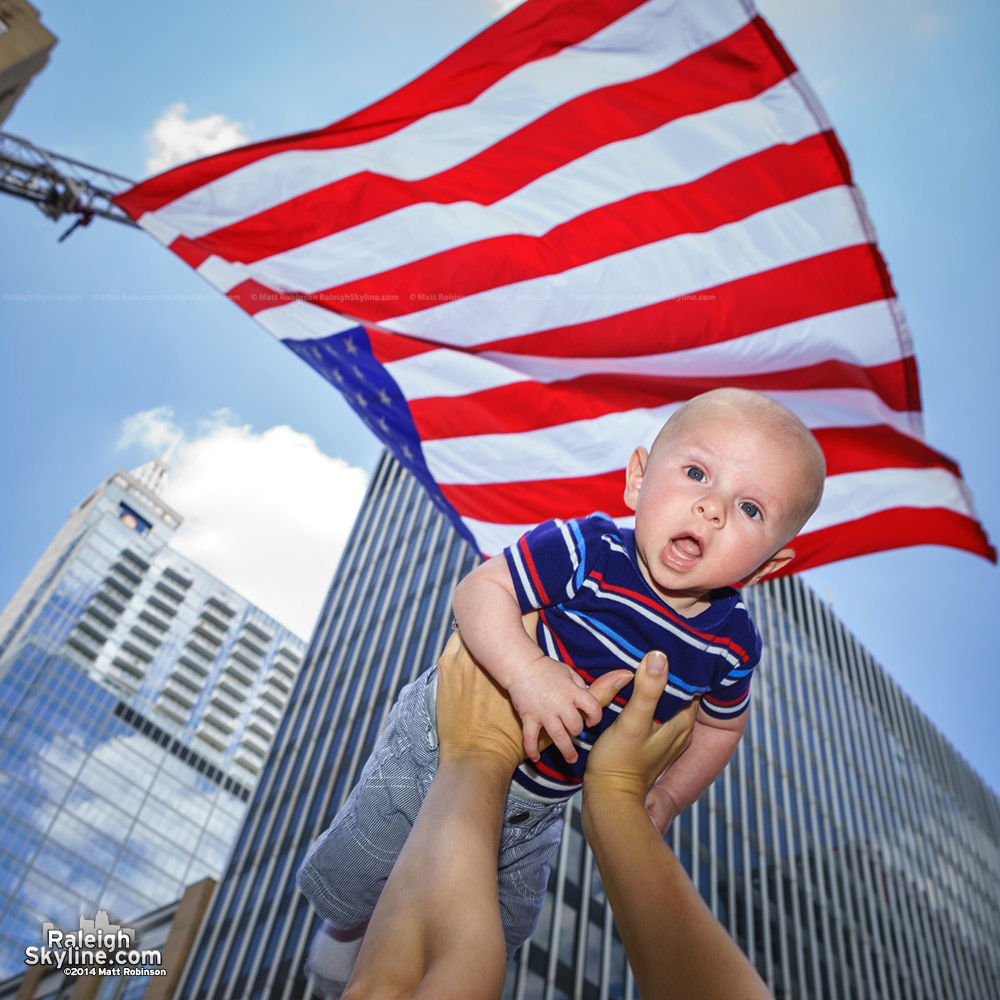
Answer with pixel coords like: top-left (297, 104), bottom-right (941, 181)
top-left (626, 411), bottom-right (803, 610)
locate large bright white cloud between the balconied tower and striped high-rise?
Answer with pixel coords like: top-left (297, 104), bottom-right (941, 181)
top-left (119, 406), bottom-right (367, 639)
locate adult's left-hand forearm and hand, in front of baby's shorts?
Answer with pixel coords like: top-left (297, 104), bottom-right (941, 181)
top-left (344, 623), bottom-right (632, 1000)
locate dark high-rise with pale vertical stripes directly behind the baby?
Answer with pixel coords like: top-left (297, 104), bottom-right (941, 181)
top-left (179, 459), bottom-right (1000, 1000)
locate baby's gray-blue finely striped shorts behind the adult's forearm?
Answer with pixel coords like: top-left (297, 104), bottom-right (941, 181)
top-left (298, 667), bottom-right (564, 957)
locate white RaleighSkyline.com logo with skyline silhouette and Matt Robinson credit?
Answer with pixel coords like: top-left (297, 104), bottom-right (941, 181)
top-left (24, 910), bottom-right (167, 976)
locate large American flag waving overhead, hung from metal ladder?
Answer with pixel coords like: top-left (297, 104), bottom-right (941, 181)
top-left (116, 0), bottom-right (996, 569)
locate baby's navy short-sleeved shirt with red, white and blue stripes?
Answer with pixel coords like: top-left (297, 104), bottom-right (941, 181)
top-left (504, 514), bottom-right (761, 800)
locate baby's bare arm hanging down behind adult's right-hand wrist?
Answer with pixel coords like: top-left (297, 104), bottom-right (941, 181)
top-left (646, 709), bottom-right (747, 833)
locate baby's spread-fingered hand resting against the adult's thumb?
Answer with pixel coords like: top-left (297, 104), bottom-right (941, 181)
top-left (507, 656), bottom-right (603, 764)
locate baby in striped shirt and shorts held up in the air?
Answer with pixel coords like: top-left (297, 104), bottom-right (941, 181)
top-left (299, 389), bottom-right (825, 996)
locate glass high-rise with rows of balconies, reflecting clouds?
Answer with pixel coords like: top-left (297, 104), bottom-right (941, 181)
top-left (0, 461), bottom-right (305, 978)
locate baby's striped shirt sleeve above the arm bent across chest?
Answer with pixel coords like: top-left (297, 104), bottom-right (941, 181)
top-left (504, 517), bottom-right (614, 614)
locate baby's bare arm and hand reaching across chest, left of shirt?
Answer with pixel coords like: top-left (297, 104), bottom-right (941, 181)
top-left (454, 556), bottom-right (601, 763)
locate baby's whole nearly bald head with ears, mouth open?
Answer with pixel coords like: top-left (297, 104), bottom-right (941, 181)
top-left (625, 389), bottom-right (826, 613)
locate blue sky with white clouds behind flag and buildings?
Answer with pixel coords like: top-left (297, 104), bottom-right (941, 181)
top-left (0, 0), bottom-right (1000, 790)
